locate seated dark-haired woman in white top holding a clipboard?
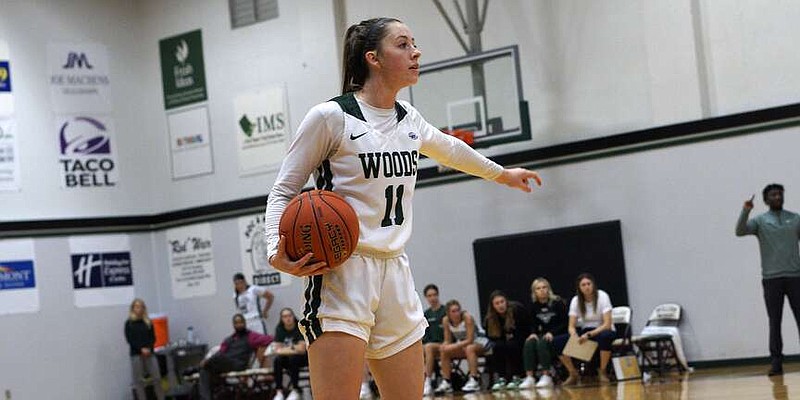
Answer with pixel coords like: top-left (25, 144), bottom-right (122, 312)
top-left (555, 273), bottom-right (616, 386)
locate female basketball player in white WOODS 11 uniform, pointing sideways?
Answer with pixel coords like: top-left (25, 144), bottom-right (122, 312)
top-left (266, 18), bottom-right (541, 400)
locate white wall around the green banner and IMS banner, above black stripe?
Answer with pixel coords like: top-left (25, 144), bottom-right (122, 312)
top-left (139, 0), bottom-right (339, 210)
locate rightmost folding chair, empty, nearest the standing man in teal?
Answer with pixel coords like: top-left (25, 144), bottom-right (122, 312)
top-left (632, 303), bottom-right (685, 377)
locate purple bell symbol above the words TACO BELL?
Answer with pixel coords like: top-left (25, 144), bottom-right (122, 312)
top-left (60, 117), bottom-right (111, 155)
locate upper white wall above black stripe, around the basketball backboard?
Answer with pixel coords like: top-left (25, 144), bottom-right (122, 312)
top-left (346, 0), bottom-right (800, 148)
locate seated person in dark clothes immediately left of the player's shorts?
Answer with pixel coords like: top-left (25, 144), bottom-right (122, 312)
top-left (272, 308), bottom-right (308, 400)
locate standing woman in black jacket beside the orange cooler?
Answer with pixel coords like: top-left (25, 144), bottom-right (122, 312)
top-left (125, 299), bottom-right (164, 400)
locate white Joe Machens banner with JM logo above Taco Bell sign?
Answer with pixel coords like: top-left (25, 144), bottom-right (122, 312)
top-left (47, 43), bottom-right (112, 114)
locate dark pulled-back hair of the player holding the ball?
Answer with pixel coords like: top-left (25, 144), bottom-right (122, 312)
top-left (342, 17), bottom-right (401, 94)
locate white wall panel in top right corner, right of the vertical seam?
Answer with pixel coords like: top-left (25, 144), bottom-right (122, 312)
top-left (698, 0), bottom-right (800, 115)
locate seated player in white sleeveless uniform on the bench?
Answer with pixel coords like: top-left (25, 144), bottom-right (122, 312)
top-left (435, 300), bottom-right (490, 393)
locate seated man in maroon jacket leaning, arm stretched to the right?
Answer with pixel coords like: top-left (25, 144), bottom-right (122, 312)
top-left (200, 314), bottom-right (272, 400)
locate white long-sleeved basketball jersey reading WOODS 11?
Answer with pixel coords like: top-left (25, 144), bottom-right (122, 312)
top-left (266, 93), bottom-right (502, 255)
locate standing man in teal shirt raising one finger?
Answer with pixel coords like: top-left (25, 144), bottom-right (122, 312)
top-left (736, 183), bottom-right (800, 376)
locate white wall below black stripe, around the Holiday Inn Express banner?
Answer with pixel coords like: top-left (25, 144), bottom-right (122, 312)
top-left (0, 233), bottom-right (159, 400)
